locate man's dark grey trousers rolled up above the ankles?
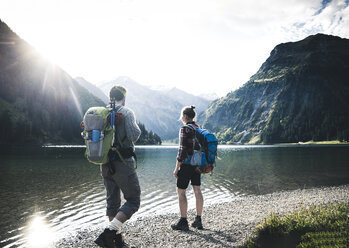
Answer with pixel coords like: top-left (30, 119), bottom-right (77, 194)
top-left (101, 159), bottom-right (141, 218)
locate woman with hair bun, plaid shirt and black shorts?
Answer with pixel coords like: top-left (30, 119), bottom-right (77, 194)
top-left (171, 106), bottom-right (204, 231)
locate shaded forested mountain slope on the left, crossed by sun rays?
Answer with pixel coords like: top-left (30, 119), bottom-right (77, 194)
top-left (0, 20), bottom-right (104, 144)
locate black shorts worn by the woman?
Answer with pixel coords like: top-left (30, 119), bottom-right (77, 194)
top-left (177, 164), bottom-right (201, 189)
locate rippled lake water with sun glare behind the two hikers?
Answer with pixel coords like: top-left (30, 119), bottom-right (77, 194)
top-left (0, 145), bottom-right (349, 247)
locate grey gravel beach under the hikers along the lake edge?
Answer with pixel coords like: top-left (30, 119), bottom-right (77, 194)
top-left (55, 185), bottom-right (349, 247)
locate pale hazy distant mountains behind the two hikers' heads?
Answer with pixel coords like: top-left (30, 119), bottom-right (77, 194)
top-left (98, 77), bottom-right (209, 139)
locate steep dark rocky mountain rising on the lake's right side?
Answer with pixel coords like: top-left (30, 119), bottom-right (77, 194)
top-left (201, 34), bottom-right (349, 144)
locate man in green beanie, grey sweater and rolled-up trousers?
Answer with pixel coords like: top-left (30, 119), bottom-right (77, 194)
top-left (95, 86), bottom-right (141, 248)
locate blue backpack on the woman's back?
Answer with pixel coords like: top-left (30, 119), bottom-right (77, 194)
top-left (186, 124), bottom-right (218, 173)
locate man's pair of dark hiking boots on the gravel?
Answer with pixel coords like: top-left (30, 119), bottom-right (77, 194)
top-left (95, 228), bottom-right (129, 248)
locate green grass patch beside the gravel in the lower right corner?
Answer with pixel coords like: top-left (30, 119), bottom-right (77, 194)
top-left (244, 203), bottom-right (349, 248)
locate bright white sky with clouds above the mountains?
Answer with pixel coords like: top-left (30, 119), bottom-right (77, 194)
top-left (0, 0), bottom-right (349, 96)
